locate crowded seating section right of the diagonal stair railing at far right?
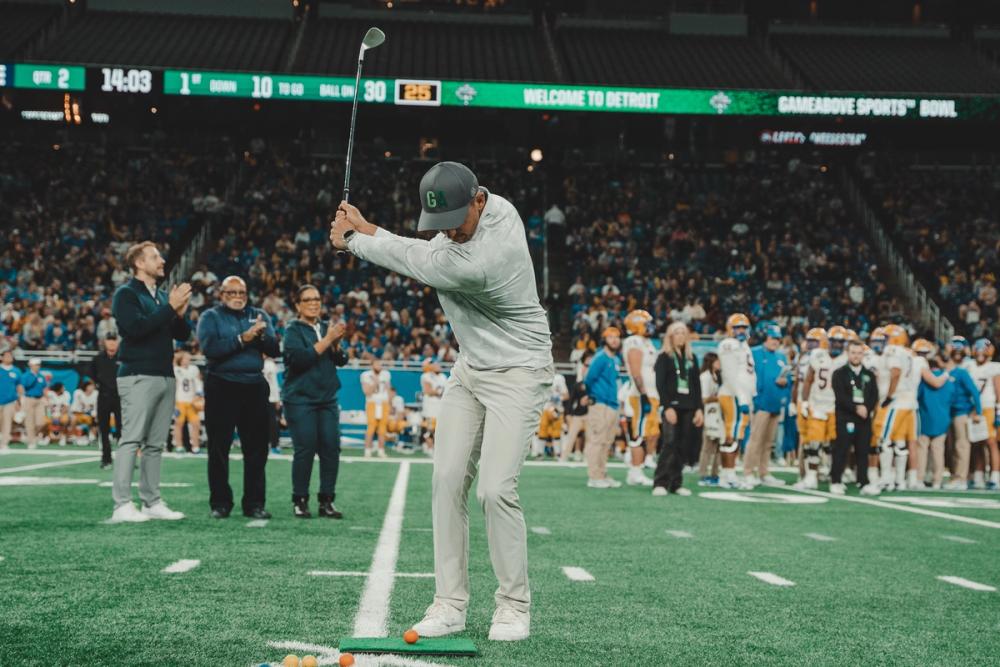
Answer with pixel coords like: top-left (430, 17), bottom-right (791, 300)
top-left (866, 157), bottom-right (1000, 337)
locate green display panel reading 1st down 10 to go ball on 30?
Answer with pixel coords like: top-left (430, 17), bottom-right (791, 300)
top-left (163, 70), bottom-right (394, 104)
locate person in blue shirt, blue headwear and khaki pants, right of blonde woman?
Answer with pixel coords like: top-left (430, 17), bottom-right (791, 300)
top-left (743, 324), bottom-right (792, 486)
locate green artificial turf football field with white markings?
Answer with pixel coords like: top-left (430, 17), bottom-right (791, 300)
top-left (0, 447), bottom-right (1000, 667)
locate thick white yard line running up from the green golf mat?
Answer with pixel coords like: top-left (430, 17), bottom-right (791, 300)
top-left (354, 462), bottom-right (410, 637)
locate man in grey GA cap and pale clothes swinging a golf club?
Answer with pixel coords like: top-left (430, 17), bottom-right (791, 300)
top-left (330, 162), bottom-right (553, 641)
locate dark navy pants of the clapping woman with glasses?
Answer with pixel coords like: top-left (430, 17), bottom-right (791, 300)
top-left (285, 402), bottom-right (340, 502)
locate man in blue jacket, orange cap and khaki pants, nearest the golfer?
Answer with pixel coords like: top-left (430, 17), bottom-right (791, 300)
top-left (583, 327), bottom-right (622, 489)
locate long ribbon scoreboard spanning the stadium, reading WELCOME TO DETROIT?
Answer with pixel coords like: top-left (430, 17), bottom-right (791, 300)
top-left (0, 63), bottom-right (1000, 120)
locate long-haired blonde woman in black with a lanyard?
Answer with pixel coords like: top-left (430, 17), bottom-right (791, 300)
top-left (653, 322), bottom-right (704, 496)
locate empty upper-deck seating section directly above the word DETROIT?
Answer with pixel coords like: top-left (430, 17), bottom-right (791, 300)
top-left (556, 27), bottom-right (789, 88)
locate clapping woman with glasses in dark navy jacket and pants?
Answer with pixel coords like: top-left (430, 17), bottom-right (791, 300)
top-left (281, 285), bottom-right (347, 519)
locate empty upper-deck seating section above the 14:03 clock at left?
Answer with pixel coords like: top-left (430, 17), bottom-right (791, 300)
top-left (38, 11), bottom-right (293, 71)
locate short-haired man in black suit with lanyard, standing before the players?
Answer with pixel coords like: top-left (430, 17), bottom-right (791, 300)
top-left (830, 340), bottom-right (878, 495)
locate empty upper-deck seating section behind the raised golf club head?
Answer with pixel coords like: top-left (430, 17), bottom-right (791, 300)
top-left (295, 19), bottom-right (552, 81)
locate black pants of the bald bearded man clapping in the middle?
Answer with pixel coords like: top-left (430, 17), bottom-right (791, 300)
top-left (205, 374), bottom-right (269, 513)
